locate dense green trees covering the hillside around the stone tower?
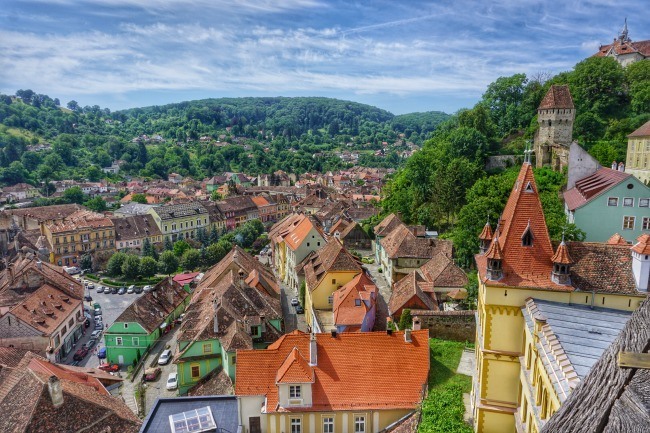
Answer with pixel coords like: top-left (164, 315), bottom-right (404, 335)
top-left (382, 57), bottom-right (650, 265)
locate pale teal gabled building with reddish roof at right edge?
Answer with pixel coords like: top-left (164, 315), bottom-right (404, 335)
top-left (564, 166), bottom-right (650, 243)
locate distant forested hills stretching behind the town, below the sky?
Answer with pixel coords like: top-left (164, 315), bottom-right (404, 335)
top-left (0, 90), bottom-right (449, 184)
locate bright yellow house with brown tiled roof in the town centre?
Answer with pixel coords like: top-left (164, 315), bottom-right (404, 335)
top-left (301, 238), bottom-right (363, 332)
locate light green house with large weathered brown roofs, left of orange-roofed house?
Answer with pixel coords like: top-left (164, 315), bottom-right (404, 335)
top-left (174, 270), bottom-right (282, 395)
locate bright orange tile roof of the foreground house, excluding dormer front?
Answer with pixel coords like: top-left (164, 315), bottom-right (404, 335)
top-left (235, 330), bottom-right (429, 413)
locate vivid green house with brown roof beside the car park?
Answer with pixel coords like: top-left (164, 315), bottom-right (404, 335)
top-left (104, 278), bottom-right (191, 365)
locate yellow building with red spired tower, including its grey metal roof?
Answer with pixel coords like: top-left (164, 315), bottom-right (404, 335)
top-left (471, 157), bottom-right (650, 433)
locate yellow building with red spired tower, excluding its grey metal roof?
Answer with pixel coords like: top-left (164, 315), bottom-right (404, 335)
top-left (472, 162), bottom-right (649, 433)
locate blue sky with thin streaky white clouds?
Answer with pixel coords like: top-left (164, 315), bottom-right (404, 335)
top-left (0, 0), bottom-right (650, 114)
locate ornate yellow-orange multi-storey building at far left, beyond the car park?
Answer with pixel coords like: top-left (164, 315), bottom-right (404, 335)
top-left (41, 210), bottom-right (115, 266)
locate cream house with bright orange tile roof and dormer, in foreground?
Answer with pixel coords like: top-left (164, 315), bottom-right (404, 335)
top-left (235, 330), bottom-right (429, 433)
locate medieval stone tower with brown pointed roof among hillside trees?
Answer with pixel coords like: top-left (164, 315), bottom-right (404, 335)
top-left (535, 85), bottom-right (576, 171)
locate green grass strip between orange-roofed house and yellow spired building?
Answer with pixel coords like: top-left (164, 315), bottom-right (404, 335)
top-left (418, 338), bottom-right (473, 433)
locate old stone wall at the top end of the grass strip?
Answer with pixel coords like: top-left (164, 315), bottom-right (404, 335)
top-left (411, 310), bottom-right (476, 343)
